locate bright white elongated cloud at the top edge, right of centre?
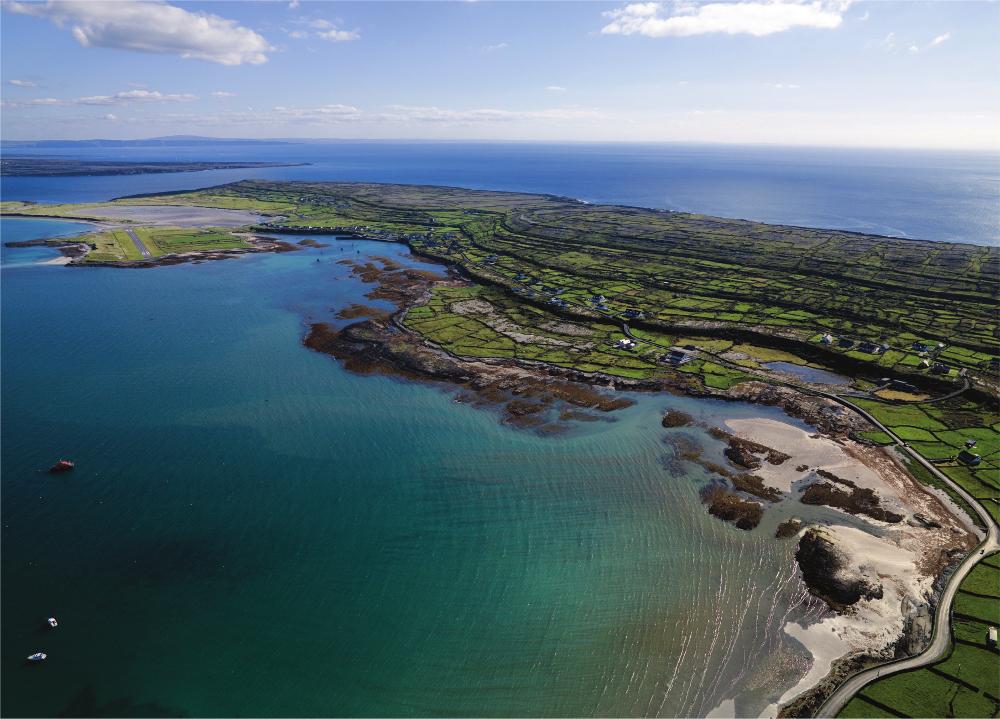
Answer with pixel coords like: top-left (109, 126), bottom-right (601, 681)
top-left (601, 0), bottom-right (851, 37)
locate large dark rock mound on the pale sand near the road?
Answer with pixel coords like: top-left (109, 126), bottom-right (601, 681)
top-left (795, 527), bottom-right (882, 612)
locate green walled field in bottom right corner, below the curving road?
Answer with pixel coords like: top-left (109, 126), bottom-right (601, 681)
top-left (839, 558), bottom-right (1000, 717)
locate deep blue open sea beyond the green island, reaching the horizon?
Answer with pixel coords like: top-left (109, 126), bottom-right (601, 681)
top-left (2, 142), bottom-right (1000, 244)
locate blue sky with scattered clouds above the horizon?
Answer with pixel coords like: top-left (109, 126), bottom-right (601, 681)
top-left (0, 0), bottom-right (1000, 150)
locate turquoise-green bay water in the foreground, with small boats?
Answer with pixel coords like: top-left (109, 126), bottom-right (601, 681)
top-left (0, 220), bottom-right (817, 716)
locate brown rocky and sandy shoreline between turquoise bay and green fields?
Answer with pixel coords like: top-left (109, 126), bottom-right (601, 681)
top-left (303, 252), bottom-right (972, 716)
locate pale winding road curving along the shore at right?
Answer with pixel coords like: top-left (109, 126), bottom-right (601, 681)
top-left (622, 322), bottom-right (1000, 717)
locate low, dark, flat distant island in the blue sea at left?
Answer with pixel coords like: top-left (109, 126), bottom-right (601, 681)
top-left (0, 157), bottom-right (309, 177)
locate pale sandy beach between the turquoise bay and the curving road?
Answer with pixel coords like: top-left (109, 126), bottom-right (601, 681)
top-left (717, 417), bottom-right (977, 716)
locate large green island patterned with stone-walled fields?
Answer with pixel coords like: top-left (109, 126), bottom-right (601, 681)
top-left (0, 181), bottom-right (1000, 716)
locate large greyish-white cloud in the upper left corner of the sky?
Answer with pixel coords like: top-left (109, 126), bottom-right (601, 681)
top-left (4, 0), bottom-right (274, 65)
